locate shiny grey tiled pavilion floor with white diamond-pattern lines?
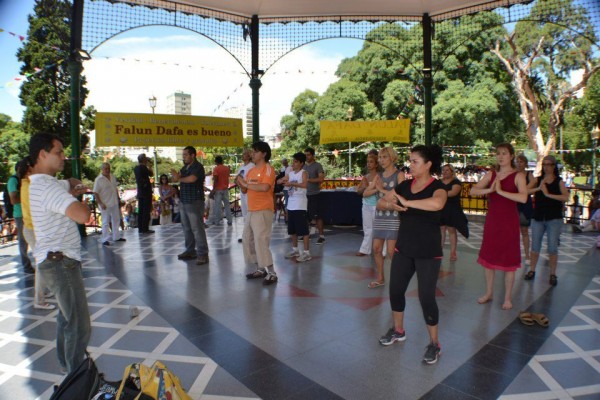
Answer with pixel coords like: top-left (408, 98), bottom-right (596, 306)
top-left (0, 221), bottom-right (600, 399)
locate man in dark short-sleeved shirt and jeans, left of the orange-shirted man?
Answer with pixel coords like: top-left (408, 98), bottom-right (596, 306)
top-left (171, 146), bottom-right (208, 265)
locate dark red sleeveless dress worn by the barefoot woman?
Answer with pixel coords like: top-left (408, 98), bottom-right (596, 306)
top-left (477, 171), bottom-right (521, 271)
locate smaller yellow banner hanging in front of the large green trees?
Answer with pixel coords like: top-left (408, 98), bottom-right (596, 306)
top-left (319, 119), bottom-right (410, 144)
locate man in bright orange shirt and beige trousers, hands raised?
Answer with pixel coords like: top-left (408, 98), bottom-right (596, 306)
top-left (237, 142), bottom-right (278, 285)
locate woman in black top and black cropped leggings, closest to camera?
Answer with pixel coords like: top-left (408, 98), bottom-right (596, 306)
top-left (377, 145), bottom-right (448, 364)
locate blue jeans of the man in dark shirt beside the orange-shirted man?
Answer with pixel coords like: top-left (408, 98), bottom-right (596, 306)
top-left (179, 200), bottom-right (208, 256)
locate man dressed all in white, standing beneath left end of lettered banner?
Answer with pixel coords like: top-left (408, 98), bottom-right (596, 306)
top-left (94, 163), bottom-right (125, 246)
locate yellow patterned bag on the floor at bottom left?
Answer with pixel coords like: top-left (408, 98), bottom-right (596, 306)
top-left (116, 361), bottom-right (192, 400)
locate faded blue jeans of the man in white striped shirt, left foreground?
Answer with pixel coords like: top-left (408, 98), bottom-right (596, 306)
top-left (38, 257), bottom-right (92, 373)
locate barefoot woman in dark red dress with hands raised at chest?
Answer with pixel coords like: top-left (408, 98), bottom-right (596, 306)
top-left (471, 143), bottom-right (527, 310)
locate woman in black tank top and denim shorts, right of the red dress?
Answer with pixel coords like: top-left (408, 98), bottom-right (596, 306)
top-left (525, 156), bottom-right (569, 286)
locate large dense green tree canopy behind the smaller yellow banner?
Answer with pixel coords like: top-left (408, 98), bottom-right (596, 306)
top-left (281, 12), bottom-right (522, 162)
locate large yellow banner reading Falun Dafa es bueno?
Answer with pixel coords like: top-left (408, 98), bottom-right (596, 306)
top-left (96, 112), bottom-right (244, 147)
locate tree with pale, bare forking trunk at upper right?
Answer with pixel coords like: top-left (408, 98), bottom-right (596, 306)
top-left (492, 0), bottom-right (600, 168)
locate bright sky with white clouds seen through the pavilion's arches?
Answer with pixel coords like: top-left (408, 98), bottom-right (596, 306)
top-left (0, 0), bottom-right (363, 135)
